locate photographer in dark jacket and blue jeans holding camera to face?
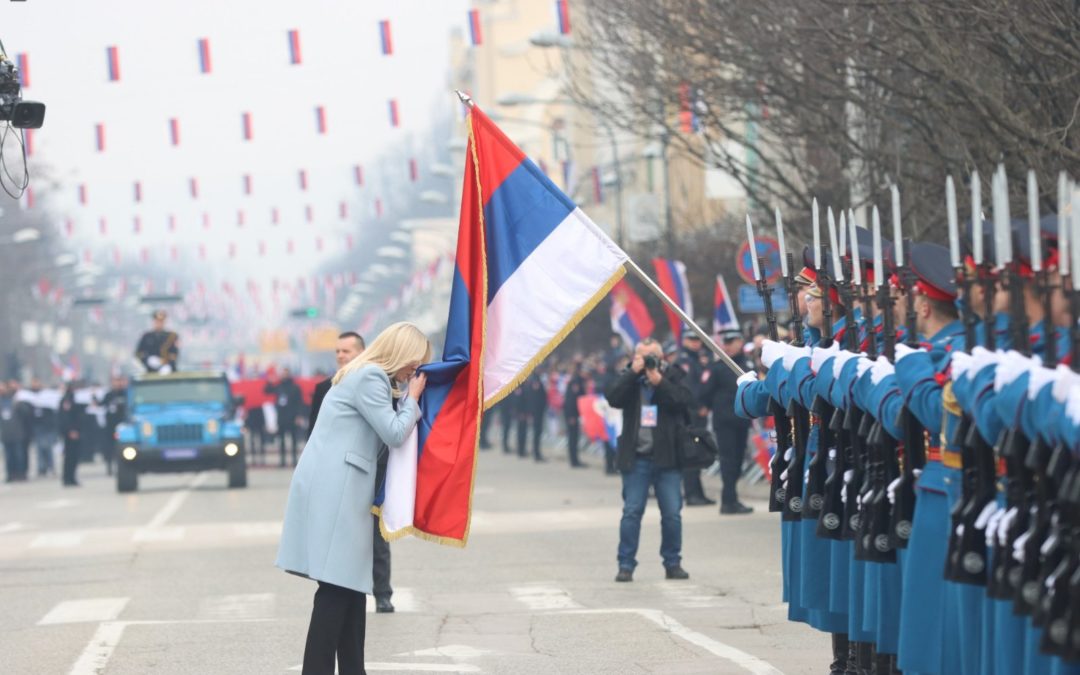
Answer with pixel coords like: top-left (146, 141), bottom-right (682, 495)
top-left (604, 338), bottom-right (692, 581)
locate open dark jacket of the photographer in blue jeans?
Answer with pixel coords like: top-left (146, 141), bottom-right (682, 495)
top-left (604, 368), bottom-right (693, 471)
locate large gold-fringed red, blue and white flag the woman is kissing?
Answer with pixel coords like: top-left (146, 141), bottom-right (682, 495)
top-left (380, 102), bottom-right (626, 546)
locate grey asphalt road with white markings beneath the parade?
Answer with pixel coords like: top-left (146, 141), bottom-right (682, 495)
top-left (0, 442), bottom-right (828, 675)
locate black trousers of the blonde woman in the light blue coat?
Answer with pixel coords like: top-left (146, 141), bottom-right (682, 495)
top-left (303, 581), bottom-right (367, 675)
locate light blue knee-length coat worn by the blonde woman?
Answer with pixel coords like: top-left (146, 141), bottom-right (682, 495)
top-left (274, 365), bottom-right (420, 593)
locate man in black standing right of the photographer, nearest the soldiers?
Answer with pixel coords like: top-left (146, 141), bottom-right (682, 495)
top-left (702, 328), bottom-right (754, 515)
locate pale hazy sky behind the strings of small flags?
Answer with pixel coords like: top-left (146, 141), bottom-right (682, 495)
top-left (0, 0), bottom-right (468, 298)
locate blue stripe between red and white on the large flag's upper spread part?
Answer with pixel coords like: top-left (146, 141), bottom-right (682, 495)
top-left (484, 160), bottom-right (576, 302)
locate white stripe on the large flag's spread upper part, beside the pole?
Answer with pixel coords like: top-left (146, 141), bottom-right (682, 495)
top-left (484, 208), bottom-right (626, 402)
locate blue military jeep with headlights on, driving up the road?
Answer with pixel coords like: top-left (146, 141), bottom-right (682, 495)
top-left (117, 372), bottom-right (247, 492)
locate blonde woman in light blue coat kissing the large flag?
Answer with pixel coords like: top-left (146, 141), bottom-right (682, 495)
top-left (275, 323), bottom-right (431, 675)
